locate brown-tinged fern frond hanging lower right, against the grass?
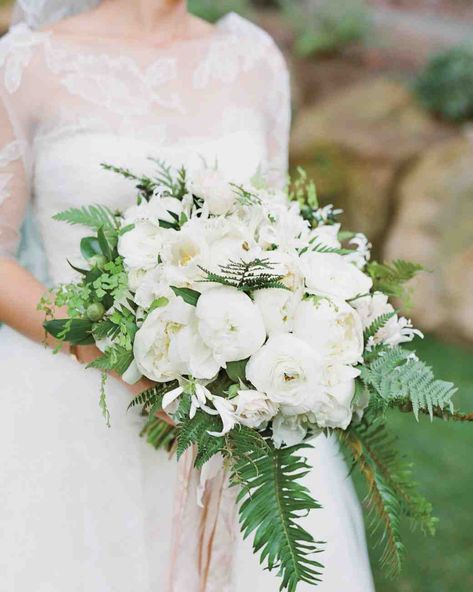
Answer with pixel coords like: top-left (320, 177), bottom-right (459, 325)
top-left (339, 420), bottom-right (437, 575)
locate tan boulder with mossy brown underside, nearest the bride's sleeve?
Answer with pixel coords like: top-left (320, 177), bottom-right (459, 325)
top-left (292, 78), bottom-right (449, 247)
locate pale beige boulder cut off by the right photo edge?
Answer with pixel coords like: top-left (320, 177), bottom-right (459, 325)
top-left (385, 138), bottom-right (473, 342)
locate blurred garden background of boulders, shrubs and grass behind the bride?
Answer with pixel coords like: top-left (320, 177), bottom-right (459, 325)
top-left (0, 0), bottom-right (473, 592)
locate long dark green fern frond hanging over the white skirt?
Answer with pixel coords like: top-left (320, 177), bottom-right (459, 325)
top-left (227, 429), bottom-right (322, 592)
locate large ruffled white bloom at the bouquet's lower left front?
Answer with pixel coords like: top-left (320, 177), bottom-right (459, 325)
top-left (133, 297), bottom-right (219, 382)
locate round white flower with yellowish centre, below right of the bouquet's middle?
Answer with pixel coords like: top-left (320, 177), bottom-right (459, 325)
top-left (246, 333), bottom-right (321, 406)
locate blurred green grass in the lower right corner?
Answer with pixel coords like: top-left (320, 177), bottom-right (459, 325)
top-left (370, 338), bottom-right (473, 592)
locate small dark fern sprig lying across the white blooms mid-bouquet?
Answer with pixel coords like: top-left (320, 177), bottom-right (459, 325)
top-left (200, 259), bottom-right (287, 293)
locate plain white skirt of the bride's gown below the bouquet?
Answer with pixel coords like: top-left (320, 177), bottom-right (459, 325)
top-left (0, 327), bottom-right (374, 592)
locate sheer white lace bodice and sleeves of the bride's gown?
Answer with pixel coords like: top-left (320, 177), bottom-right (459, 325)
top-left (0, 13), bottom-right (290, 281)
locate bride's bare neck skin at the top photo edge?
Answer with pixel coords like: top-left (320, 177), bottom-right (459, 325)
top-left (101, 0), bottom-right (190, 41)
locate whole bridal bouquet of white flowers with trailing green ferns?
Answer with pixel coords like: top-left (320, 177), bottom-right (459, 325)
top-left (43, 162), bottom-right (463, 591)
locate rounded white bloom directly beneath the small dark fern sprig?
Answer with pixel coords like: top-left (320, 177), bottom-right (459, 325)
top-left (196, 287), bottom-right (266, 365)
